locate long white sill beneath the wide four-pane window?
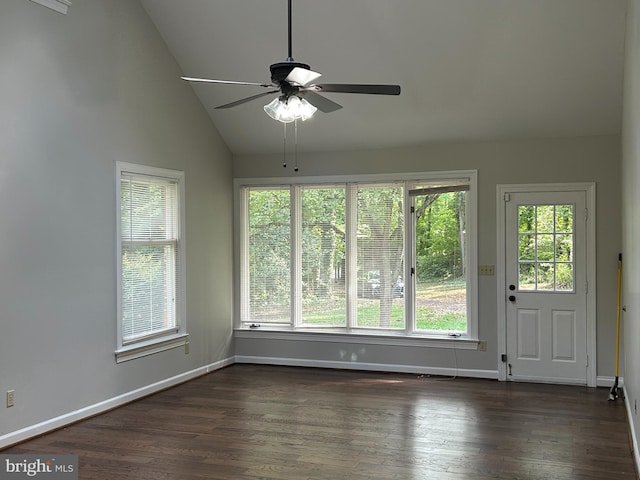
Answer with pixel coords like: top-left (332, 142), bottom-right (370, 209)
top-left (235, 326), bottom-right (479, 350)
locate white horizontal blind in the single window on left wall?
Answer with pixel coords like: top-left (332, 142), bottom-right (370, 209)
top-left (120, 172), bottom-right (179, 344)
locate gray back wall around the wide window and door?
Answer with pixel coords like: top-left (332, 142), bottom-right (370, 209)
top-left (233, 135), bottom-right (621, 377)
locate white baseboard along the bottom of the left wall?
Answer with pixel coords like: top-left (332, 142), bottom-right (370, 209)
top-left (0, 357), bottom-right (234, 449)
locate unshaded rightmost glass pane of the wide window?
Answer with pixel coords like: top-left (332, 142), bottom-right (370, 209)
top-left (415, 192), bottom-right (467, 332)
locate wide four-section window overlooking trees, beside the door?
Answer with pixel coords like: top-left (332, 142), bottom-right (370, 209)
top-left (236, 172), bottom-right (477, 339)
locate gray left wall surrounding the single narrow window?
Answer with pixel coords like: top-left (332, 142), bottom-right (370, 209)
top-left (0, 0), bottom-right (233, 446)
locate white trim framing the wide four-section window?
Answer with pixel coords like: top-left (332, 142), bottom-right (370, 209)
top-left (234, 170), bottom-right (479, 350)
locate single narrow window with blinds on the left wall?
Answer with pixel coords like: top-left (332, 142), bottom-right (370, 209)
top-left (117, 164), bottom-right (185, 360)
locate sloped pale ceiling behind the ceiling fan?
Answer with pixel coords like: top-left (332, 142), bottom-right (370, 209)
top-left (141, 0), bottom-right (627, 154)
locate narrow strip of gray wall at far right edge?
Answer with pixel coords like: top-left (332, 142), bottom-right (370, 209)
top-left (621, 0), bottom-right (640, 464)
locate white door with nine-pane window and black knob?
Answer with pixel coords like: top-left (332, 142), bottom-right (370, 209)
top-left (503, 191), bottom-right (588, 384)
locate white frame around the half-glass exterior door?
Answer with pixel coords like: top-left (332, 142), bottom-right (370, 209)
top-left (496, 183), bottom-right (597, 387)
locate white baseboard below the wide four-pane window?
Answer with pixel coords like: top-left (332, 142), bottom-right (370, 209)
top-left (235, 355), bottom-right (498, 380)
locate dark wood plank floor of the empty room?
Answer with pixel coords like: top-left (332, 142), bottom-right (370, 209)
top-left (2, 365), bottom-right (636, 480)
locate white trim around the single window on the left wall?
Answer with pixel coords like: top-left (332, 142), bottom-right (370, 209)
top-left (115, 162), bottom-right (189, 363)
